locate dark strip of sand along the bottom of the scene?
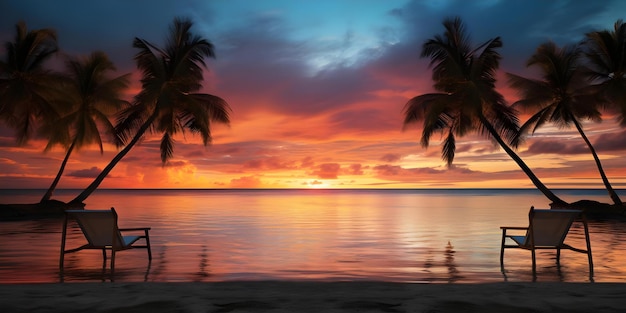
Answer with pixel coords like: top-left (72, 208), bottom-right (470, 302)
top-left (0, 281), bottom-right (626, 313)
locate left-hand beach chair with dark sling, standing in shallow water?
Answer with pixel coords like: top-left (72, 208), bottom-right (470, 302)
top-left (59, 208), bottom-right (152, 272)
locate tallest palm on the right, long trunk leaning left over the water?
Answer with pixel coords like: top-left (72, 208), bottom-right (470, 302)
top-left (404, 18), bottom-right (566, 205)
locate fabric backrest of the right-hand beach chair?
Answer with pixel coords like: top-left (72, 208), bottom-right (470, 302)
top-left (525, 208), bottom-right (582, 247)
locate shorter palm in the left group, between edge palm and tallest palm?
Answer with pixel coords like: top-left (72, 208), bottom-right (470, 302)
top-left (41, 52), bottom-right (130, 202)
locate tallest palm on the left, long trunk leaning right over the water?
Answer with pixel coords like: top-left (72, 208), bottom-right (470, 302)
top-left (71, 18), bottom-right (230, 203)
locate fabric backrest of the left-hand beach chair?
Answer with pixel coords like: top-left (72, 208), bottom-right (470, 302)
top-left (65, 208), bottom-right (124, 247)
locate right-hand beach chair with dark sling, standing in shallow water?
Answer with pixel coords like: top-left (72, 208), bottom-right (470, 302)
top-left (500, 207), bottom-right (593, 276)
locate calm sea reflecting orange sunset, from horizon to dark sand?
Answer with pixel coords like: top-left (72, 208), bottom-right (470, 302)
top-left (0, 190), bottom-right (626, 283)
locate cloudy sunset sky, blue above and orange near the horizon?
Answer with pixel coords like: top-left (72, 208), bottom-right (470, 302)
top-left (0, 0), bottom-right (626, 188)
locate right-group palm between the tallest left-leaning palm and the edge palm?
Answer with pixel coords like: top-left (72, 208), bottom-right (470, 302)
top-left (507, 42), bottom-right (622, 204)
